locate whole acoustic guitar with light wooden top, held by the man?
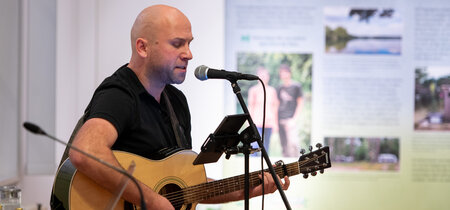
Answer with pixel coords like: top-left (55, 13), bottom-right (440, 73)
top-left (53, 147), bottom-right (331, 210)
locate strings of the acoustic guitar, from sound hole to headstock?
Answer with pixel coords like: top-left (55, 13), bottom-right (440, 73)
top-left (163, 154), bottom-right (324, 206)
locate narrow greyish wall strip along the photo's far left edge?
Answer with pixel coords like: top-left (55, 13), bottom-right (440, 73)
top-left (0, 0), bottom-right (20, 185)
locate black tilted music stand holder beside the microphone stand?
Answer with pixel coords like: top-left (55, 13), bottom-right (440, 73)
top-left (193, 114), bottom-right (249, 165)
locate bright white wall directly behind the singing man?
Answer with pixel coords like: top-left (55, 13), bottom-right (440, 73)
top-left (21, 0), bottom-right (225, 207)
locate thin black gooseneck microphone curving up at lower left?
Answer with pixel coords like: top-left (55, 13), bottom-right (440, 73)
top-left (23, 122), bottom-right (147, 210)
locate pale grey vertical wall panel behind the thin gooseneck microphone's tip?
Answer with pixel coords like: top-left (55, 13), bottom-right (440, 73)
top-left (16, 0), bottom-right (56, 207)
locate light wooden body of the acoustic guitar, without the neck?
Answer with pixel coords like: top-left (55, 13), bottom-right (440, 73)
top-left (53, 150), bottom-right (207, 210)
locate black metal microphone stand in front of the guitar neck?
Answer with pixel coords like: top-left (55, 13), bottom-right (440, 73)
top-left (228, 78), bottom-right (292, 210)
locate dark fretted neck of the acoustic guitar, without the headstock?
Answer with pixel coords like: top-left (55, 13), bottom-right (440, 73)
top-left (168, 162), bottom-right (300, 203)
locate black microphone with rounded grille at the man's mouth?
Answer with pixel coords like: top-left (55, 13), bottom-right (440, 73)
top-left (194, 65), bottom-right (259, 82)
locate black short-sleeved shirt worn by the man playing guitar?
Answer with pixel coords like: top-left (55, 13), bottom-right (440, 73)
top-left (85, 64), bottom-right (192, 158)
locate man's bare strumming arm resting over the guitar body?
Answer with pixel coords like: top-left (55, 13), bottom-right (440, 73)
top-left (69, 118), bottom-right (174, 209)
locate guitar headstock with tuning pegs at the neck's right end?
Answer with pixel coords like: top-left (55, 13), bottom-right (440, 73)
top-left (298, 144), bottom-right (331, 179)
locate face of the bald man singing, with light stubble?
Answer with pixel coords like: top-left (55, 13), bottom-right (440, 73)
top-left (149, 17), bottom-right (193, 84)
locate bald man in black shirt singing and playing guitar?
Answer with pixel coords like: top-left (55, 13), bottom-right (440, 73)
top-left (62, 5), bottom-right (289, 209)
